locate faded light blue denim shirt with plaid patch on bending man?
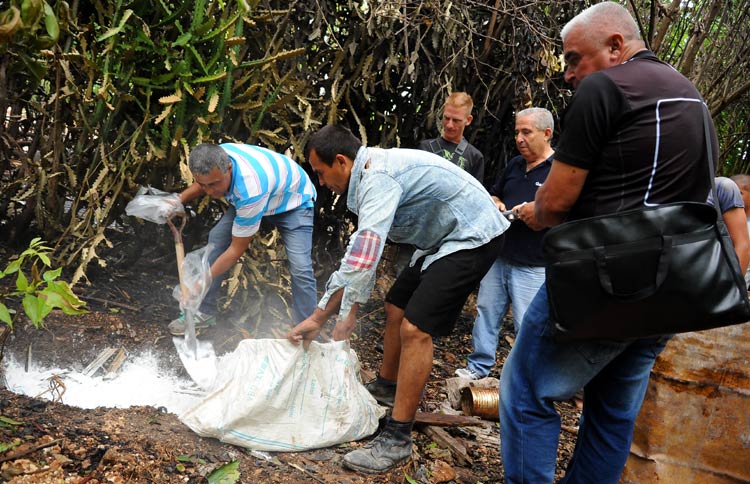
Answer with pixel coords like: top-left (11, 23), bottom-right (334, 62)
top-left (318, 147), bottom-right (510, 318)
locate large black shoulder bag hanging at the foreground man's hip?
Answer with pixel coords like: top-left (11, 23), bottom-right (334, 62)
top-left (544, 202), bottom-right (750, 341)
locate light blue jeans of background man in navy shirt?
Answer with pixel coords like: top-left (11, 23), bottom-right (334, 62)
top-left (468, 257), bottom-right (544, 377)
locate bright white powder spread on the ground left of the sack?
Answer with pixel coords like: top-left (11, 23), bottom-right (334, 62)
top-left (3, 353), bottom-right (203, 415)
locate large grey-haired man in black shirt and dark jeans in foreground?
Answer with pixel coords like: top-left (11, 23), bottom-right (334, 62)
top-left (500, 2), bottom-right (718, 484)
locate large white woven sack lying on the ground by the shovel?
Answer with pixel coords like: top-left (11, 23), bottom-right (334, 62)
top-left (180, 339), bottom-right (385, 452)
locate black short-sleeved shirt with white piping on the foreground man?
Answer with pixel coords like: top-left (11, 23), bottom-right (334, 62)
top-left (555, 51), bottom-right (718, 220)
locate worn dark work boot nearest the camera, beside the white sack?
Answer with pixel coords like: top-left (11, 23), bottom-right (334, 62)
top-left (344, 417), bottom-right (414, 474)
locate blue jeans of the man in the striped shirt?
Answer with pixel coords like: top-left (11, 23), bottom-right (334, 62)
top-left (200, 205), bottom-right (318, 322)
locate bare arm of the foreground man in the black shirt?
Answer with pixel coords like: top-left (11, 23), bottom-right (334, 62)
top-left (534, 160), bottom-right (589, 227)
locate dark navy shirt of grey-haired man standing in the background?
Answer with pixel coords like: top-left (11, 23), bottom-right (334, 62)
top-left (490, 155), bottom-right (555, 266)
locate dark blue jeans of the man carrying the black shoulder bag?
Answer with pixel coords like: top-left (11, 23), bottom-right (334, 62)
top-left (500, 285), bottom-right (669, 484)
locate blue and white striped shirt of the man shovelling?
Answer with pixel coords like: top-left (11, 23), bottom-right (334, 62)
top-left (219, 143), bottom-right (317, 237)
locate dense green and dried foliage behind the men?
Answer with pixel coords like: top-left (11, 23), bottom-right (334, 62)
top-left (0, 0), bottom-right (750, 302)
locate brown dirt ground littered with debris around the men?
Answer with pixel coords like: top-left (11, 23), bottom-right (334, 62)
top-left (0, 232), bottom-right (580, 484)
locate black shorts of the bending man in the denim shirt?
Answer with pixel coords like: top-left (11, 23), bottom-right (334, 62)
top-left (385, 235), bottom-right (504, 336)
